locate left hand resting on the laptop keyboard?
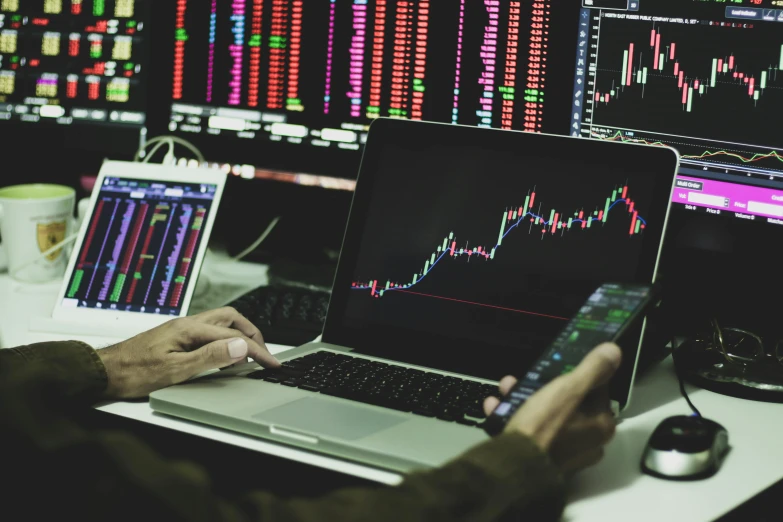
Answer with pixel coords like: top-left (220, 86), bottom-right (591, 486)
top-left (98, 307), bottom-right (280, 399)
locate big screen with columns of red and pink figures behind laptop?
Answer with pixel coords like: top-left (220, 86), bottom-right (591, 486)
top-left (168, 0), bottom-right (579, 178)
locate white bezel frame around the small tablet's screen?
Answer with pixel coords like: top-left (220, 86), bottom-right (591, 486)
top-left (52, 161), bottom-right (227, 332)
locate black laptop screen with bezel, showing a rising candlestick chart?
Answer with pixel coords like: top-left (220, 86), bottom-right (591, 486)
top-left (324, 124), bottom-right (676, 366)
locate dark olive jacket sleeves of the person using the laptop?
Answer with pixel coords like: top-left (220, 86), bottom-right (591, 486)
top-left (0, 342), bottom-right (564, 522)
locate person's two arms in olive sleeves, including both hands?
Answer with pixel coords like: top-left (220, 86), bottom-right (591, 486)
top-left (0, 309), bottom-right (621, 522)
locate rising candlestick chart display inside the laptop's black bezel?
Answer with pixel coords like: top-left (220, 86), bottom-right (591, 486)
top-left (346, 142), bottom-right (658, 346)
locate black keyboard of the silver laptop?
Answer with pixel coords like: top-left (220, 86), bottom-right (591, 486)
top-left (248, 351), bottom-right (499, 426)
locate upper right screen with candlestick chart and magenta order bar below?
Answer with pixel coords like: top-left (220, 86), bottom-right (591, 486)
top-left (571, 0), bottom-right (783, 225)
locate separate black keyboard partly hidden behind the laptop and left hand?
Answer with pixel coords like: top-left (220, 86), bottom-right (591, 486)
top-left (229, 286), bottom-right (329, 346)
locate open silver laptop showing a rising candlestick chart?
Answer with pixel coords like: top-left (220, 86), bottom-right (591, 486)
top-left (150, 119), bottom-right (679, 473)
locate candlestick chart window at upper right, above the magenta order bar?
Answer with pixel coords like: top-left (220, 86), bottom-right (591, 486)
top-left (577, 0), bottom-right (783, 171)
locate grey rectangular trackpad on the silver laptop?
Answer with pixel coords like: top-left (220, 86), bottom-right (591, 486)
top-left (253, 397), bottom-right (409, 440)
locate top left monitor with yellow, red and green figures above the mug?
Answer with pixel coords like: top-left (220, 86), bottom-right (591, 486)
top-left (0, 0), bottom-right (152, 126)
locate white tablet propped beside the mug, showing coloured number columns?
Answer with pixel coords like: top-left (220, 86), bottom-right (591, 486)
top-left (30, 161), bottom-right (226, 338)
